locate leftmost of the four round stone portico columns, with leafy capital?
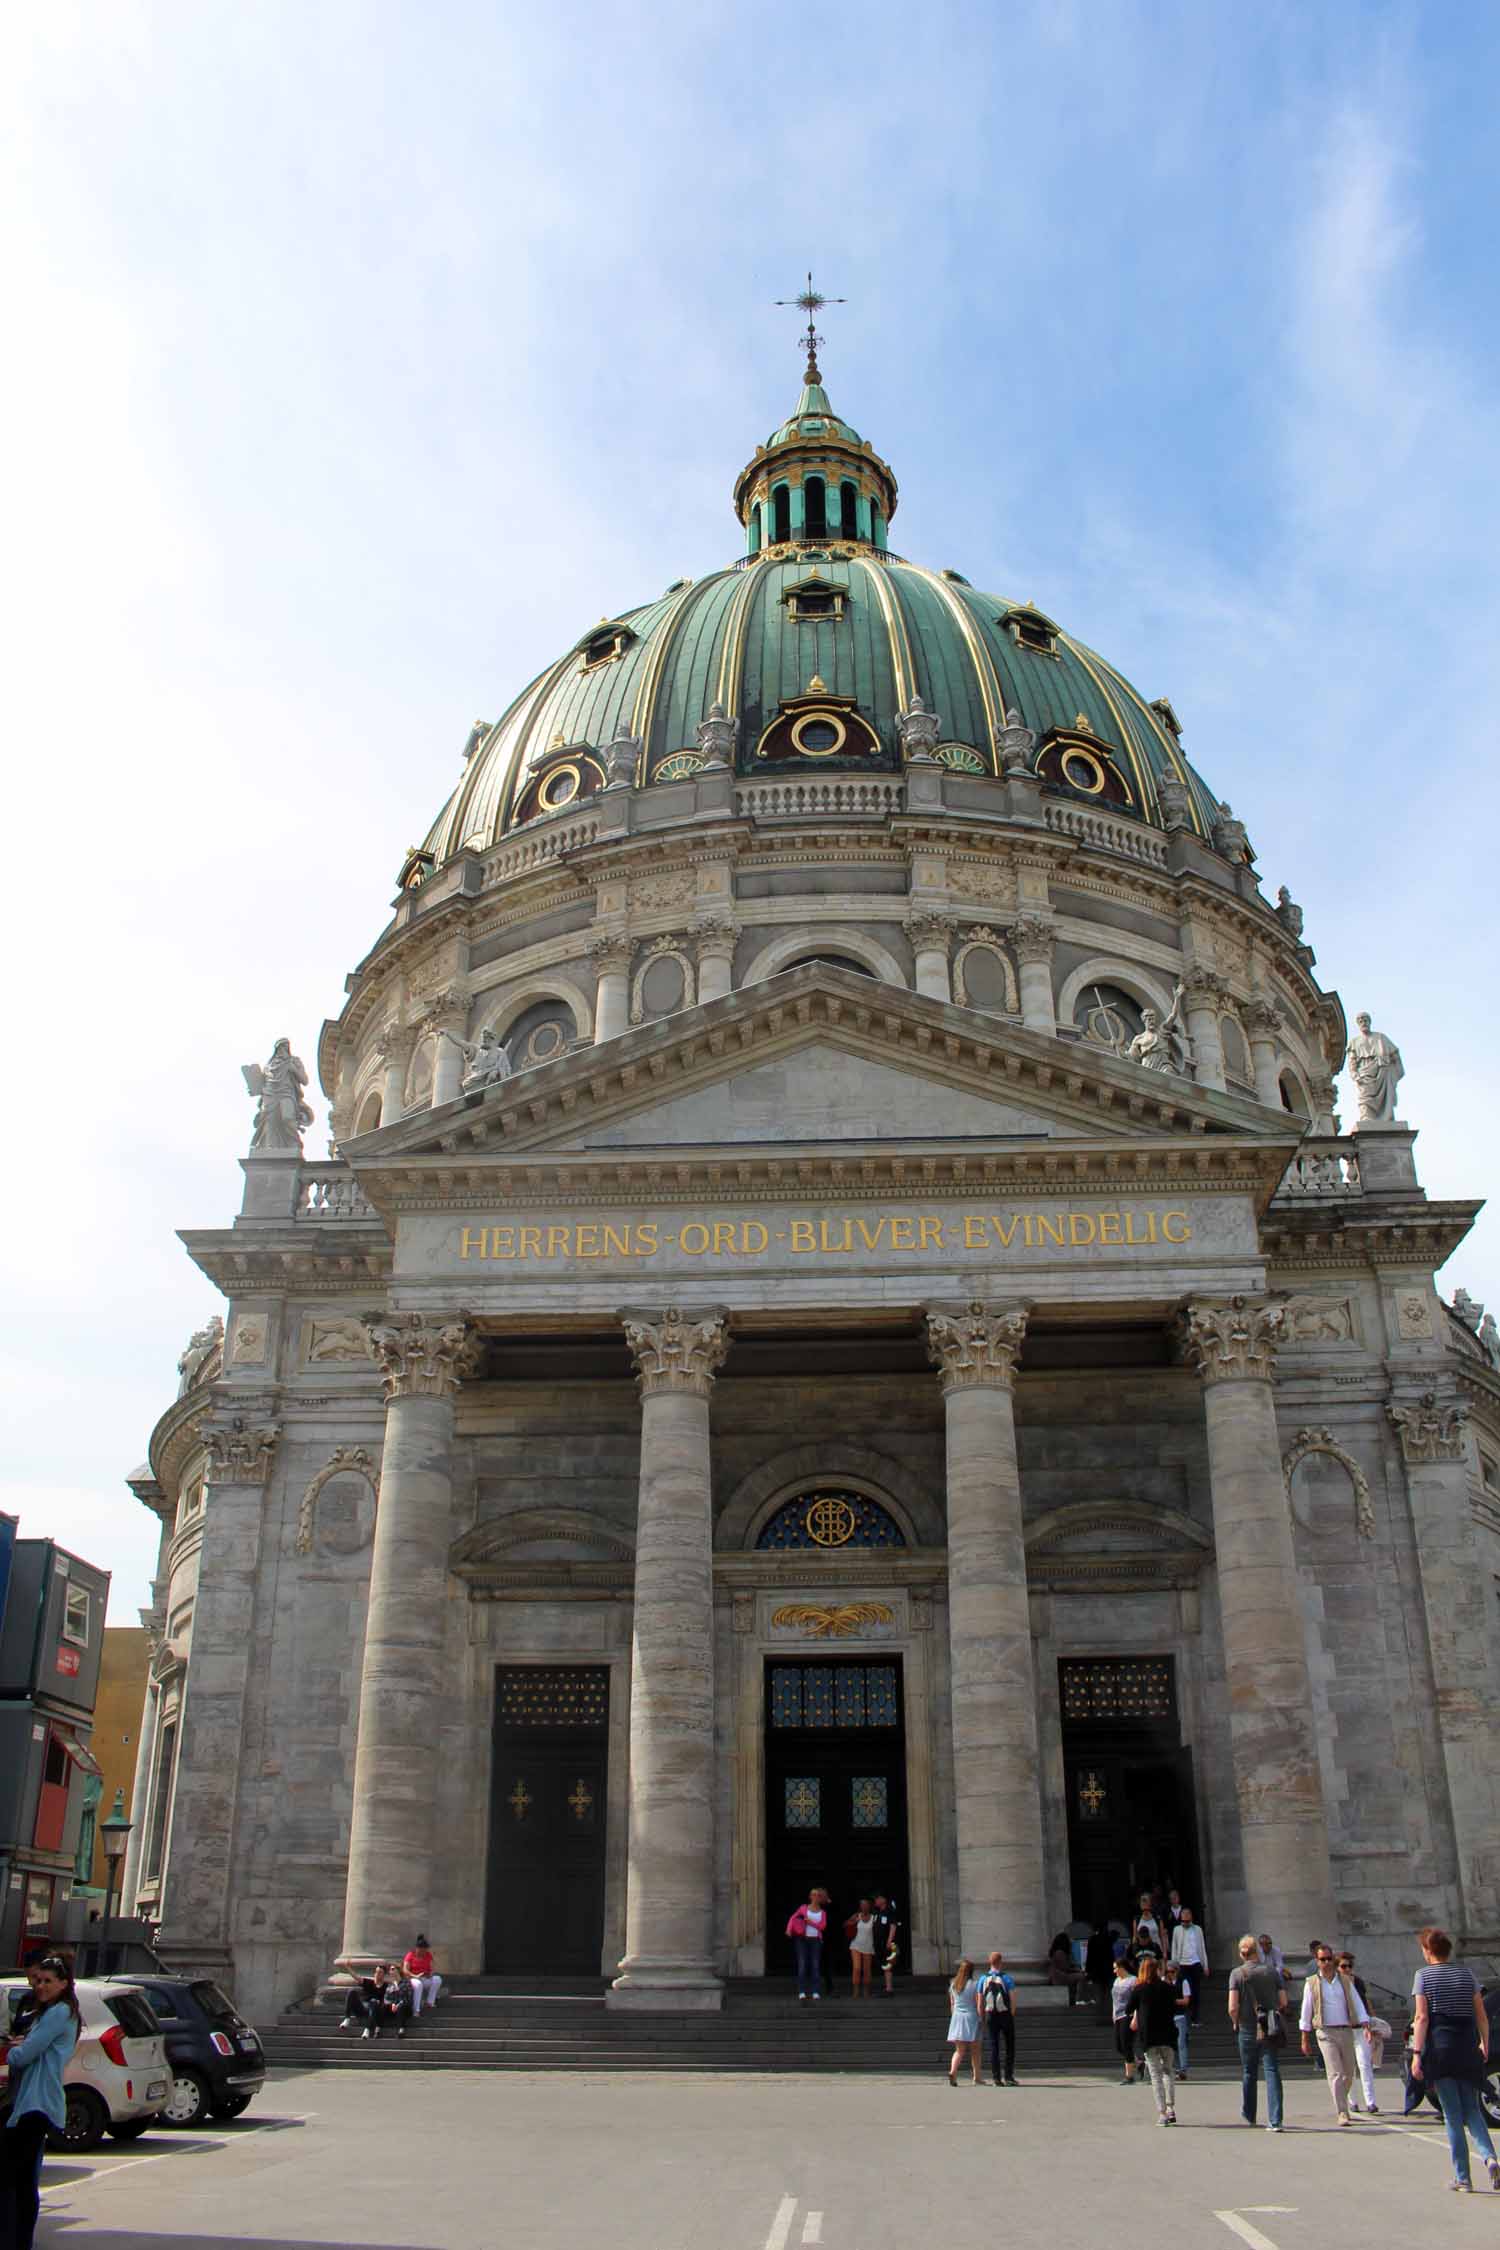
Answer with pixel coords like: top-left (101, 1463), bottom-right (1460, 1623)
top-left (337, 1312), bottom-right (479, 1976)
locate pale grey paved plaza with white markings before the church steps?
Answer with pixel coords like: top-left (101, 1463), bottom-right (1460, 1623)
top-left (38, 2045), bottom-right (1500, 2250)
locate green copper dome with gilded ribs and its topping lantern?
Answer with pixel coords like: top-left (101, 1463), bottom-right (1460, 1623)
top-left (421, 362), bottom-right (1217, 864)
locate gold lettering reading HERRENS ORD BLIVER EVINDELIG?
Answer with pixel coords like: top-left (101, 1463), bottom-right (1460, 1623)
top-left (459, 1204), bottom-right (1192, 1265)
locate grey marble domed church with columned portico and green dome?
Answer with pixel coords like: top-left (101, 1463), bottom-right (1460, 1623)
top-left (126, 321), bottom-right (1500, 2018)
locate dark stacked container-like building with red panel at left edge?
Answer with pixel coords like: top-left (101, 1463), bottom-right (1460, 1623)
top-left (0, 1519), bottom-right (110, 1964)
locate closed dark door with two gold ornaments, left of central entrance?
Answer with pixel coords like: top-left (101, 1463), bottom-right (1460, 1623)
top-left (484, 1665), bottom-right (609, 1976)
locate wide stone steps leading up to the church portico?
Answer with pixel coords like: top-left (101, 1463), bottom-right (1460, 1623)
top-left (261, 1978), bottom-right (1239, 2079)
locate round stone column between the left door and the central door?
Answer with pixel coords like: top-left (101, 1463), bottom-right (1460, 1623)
top-left (609, 1305), bottom-right (729, 2009)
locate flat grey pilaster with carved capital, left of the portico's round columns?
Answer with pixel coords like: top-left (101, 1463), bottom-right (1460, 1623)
top-left (162, 1415), bottom-right (279, 1969)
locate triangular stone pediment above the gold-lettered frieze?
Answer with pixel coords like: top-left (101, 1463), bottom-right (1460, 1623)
top-left (344, 963), bottom-right (1295, 1202)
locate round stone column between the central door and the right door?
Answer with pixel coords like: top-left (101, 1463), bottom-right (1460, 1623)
top-left (927, 1305), bottom-right (1046, 1960)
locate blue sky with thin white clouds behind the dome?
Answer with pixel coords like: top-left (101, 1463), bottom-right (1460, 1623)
top-left (0, 0), bottom-right (1500, 1622)
